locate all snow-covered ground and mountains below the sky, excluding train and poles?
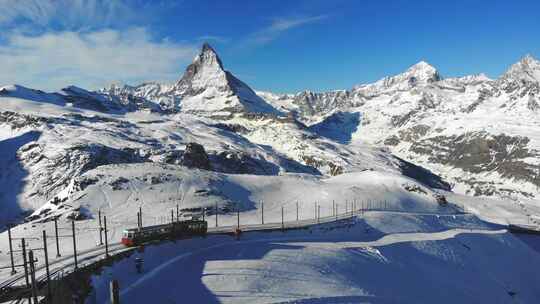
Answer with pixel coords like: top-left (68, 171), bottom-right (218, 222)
top-left (0, 44), bottom-right (540, 303)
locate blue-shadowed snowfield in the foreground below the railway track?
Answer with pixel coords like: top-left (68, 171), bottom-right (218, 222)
top-left (88, 212), bottom-right (540, 303)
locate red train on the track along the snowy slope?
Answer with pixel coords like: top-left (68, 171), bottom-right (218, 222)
top-left (122, 219), bottom-right (208, 246)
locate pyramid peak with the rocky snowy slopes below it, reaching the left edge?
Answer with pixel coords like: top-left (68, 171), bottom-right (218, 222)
top-left (0, 44), bottom-right (449, 226)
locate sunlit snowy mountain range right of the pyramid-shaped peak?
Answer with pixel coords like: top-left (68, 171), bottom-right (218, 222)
top-left (259, 56), bottom-right (540, 199)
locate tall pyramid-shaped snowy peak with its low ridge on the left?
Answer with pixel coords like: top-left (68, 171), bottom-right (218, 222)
top-left (101, 43), bottom-right (276, 116)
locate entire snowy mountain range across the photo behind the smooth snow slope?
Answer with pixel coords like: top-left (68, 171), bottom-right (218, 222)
top-left (0, 44), bottom-right (540, 223)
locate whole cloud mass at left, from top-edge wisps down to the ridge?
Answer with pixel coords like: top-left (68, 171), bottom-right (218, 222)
top-left (0, 0), bottom-right (200, 90)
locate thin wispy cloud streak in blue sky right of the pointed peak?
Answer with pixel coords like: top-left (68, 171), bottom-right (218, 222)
top-left (245, 15), bottom-right (328, 46)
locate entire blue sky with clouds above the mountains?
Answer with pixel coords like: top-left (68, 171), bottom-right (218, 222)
top-left (0, 0), bottom-right (540, 92)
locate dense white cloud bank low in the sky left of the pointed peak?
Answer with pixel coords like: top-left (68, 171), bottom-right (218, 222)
top-left (0, 28), bottom-right (197, 90)
